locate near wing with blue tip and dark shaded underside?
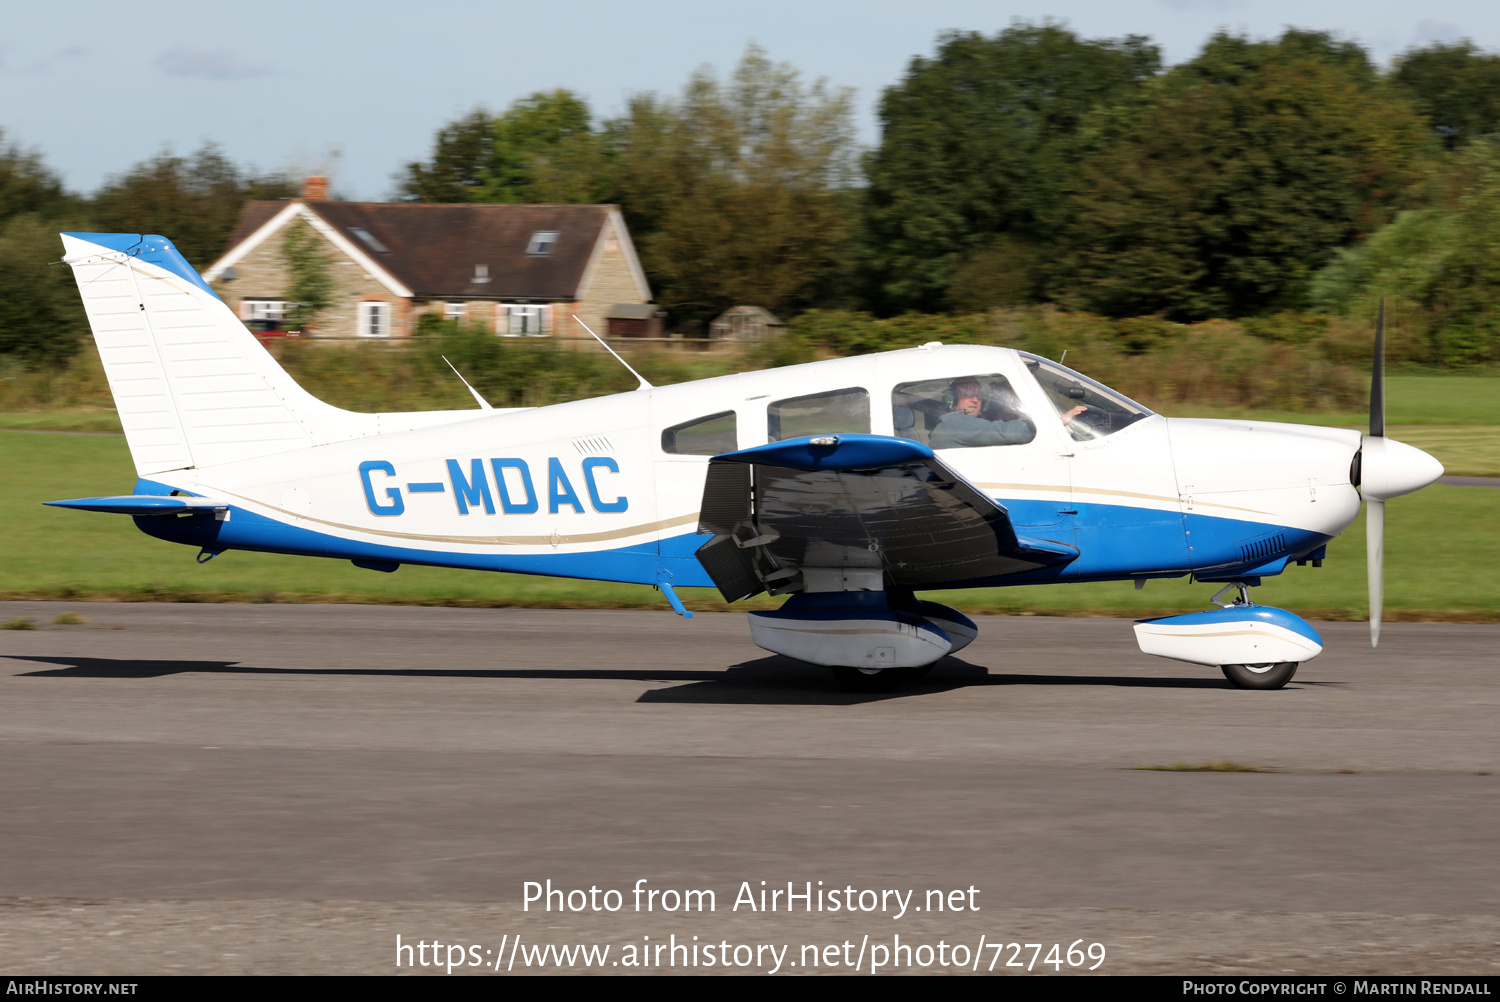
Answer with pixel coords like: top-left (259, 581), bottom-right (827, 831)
top-left (698, 435), bottom-right (1079, 602)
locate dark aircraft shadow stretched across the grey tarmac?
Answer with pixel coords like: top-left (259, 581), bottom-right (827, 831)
top-left (6, 654), bottom-right (1233, 707)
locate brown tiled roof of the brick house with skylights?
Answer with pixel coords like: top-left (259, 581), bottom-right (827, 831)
top-left (230, 201), bottom-right (614, 300)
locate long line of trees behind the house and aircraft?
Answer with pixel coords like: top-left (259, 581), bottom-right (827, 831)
top-left (0, 23), bottom-right (1500, 365)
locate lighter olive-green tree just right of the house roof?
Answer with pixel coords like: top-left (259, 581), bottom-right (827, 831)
top-left (612, 47), bottom-right (857, 324)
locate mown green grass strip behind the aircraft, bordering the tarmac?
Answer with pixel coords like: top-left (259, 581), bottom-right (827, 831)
top-left (0, 431), bottom-right (1500, 623)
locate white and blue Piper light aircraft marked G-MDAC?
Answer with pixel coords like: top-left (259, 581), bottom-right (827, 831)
top-left (48, 233), bottom-right (1443, 692)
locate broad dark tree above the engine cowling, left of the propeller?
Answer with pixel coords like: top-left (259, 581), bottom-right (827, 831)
top-left (1047, 32), bottom-right (1434, 321)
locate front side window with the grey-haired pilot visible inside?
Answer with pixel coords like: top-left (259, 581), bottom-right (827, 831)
top-left (891, 372), bottom-right (1037, 449)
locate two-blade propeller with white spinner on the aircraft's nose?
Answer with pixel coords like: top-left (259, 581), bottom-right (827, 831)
top-left (1359, 296), bottom-right (1443, 647)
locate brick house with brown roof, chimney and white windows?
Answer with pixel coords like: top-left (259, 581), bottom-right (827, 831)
top-left (204, 177), bottom-right (656, 346)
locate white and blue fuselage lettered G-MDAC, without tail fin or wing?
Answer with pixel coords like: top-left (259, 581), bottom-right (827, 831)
top-left (137, 345), bottom-right (1361, 587)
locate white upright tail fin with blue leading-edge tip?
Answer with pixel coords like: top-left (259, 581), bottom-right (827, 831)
top-left (62, 233), bottom-right (380, 476)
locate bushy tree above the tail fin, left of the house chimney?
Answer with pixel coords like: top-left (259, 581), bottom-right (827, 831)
top-left (90, 143), bottom-right (297, 270)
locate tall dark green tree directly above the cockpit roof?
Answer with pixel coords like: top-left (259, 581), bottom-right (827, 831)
top-left (864, 23), bottom-right (1161, 311)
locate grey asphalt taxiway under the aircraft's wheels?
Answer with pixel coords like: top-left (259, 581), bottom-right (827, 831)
top-left (0, 603), bottom-right (1500, 975)
